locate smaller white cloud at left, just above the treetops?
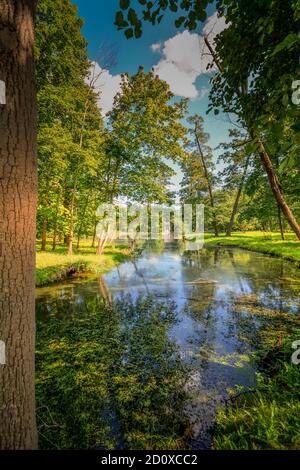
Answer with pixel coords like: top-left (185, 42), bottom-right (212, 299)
top-left (90, 62), bottom-right (121, 115)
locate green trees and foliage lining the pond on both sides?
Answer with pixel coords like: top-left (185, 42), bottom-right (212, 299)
top-left (36, 0), bottom-right (300, 254)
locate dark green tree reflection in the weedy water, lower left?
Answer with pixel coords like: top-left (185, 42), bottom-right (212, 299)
top-left (37, 296), bottom-right (189, 449)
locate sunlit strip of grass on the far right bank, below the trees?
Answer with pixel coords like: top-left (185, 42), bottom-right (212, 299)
top-left (205, 232), bottom-right (300, 264)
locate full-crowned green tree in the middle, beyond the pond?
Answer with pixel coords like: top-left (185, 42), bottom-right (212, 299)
top-left (97, 67), bottom-right (186, 254)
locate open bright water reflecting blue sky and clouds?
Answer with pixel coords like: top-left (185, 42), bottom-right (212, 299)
top-left (38, 246), bottom-right (300, 448)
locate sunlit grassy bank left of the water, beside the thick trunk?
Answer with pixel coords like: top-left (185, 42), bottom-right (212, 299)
top-left (36, 242), bottom-right (130, 287)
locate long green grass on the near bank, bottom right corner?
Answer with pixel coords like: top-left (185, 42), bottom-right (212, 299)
top-left (214, 329), bottom-right (300, 450)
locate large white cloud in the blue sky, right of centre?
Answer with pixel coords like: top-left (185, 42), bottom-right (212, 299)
top-left (151, 13), bottom-right (225, 99)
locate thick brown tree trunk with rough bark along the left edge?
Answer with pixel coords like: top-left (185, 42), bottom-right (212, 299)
top-left (0, 0), bottom-right (37, 449)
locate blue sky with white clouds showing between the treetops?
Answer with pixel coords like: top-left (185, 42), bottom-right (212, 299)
top-left (73, 0), bottom-right (230, 189)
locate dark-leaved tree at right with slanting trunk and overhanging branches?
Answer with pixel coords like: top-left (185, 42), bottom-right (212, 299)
top-left (115, 0), bottom-right (300, 239)
